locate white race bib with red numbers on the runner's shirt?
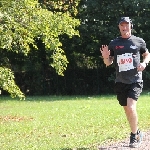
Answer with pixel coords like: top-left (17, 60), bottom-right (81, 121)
top-left (117, 53), bottom-right (134, 72)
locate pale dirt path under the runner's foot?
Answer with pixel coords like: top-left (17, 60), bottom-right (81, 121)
top-left (98, 131), bottom-right (150, 150)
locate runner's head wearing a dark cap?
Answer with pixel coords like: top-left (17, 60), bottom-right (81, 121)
top-left (119, 17), bottom-right (133, 38)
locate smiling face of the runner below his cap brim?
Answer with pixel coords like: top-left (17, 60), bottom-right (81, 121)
top-left (119, 22), bottom-right (131, 36)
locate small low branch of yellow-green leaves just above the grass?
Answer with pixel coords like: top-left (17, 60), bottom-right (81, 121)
top-left (0, 67), bottom-right (25, 99)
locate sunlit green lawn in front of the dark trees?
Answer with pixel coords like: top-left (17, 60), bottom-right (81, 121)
top-left (0, 94), bottom-right (150, 150)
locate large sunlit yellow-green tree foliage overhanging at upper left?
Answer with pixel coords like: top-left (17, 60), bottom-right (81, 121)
top-left (0, 0), bottom-right (80, 97)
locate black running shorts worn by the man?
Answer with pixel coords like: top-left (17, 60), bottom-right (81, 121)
top-left (114, 82), bottom-right (143, 106)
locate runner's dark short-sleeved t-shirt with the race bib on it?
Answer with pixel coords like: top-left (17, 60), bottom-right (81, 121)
top-left (108, 35), bottom-right (148, 84)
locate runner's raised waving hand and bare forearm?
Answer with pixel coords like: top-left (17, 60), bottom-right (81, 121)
top-left (100, 45), bottom-right (114, 66)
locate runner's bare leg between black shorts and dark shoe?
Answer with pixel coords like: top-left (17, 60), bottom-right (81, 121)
top-left (123, 98), bottom-right (138, 134)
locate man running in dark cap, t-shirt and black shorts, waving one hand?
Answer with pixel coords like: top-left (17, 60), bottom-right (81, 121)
top-left (100, 17), bottom-right (150, 148)
